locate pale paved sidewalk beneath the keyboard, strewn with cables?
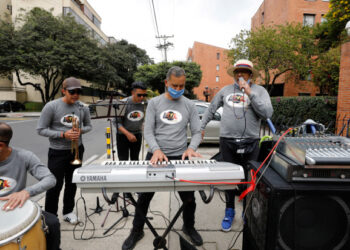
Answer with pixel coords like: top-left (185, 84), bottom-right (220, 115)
top-left (39, 147), bottom-right (242, 250)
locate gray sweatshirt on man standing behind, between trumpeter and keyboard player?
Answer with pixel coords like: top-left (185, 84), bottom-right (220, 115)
top-left (113, 96), bottom-right (146, 134)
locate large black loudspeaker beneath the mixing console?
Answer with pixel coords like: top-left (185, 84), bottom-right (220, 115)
top-left (243, 162), bottom-right (350, 250)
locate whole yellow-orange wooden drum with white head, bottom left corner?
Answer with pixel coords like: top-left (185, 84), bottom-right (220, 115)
top-left (0, 200), bottom-right (46, 250)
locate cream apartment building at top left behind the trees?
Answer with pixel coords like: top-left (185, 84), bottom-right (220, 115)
top-left (0, 0), bottom-right (112, 102)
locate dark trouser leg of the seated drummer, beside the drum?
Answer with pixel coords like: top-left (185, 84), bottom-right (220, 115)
top-left (42, 211), bottom-right (61, 250)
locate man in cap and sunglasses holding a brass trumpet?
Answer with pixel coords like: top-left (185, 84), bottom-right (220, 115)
top-left (37, 77), bottom-right (92, 224)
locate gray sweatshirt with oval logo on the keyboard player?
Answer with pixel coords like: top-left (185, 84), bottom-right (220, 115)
top-left (144, 94), bottom-right (201, 156)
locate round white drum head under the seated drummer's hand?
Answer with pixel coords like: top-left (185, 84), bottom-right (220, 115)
top-left (0, 200), bottom-right (40, 246)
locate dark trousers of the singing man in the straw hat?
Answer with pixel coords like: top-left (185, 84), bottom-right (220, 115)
top-left (220, 137), bottom-right (259, 208)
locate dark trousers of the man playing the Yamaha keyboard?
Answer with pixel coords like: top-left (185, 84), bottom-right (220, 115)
top-left (133, 153), bottom-right (196, 231)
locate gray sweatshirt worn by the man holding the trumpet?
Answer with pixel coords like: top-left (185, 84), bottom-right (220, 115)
top-left (36, 98), bottom-right (92, 150)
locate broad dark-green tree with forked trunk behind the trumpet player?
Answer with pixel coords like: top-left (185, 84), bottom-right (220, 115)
top-left (14, 8), bottom-right (100, 103)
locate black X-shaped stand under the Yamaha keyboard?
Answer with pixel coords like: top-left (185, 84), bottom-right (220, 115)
top-left (130, 197), bottom-right (184, 250)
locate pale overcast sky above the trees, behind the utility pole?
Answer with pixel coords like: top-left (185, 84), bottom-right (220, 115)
top-left (89, 0), bottom-right (263, 62)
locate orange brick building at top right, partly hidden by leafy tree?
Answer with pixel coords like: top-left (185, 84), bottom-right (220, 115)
top-left (251, 0), bottom-right (329, 96)
